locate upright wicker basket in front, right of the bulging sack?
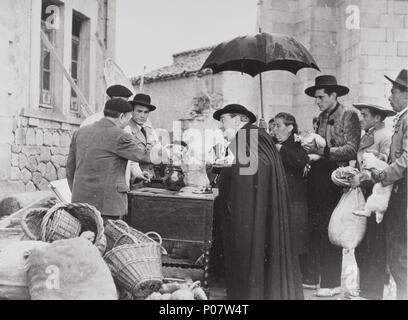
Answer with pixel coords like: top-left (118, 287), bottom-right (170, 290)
top-left (104, 234), bottom-right (163, 297)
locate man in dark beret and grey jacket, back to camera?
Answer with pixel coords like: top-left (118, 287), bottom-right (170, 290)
top-left (67, 98), bottom-right (159, 220)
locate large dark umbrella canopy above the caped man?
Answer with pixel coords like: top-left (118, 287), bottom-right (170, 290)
top-left (201, 32), bottom-right (320, 77)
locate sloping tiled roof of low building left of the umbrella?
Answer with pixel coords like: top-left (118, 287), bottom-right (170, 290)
top-left (131, 47), bottom-right (214, 85)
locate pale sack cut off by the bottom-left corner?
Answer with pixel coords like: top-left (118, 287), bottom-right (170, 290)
top-left (0, 241), bottom-right (48, 300)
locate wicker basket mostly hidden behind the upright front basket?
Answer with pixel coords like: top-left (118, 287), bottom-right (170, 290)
top-left (105, 220), bottom-right (167, 254)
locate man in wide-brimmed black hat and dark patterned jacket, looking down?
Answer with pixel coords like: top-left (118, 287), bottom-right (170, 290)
top-left (301, 75), bottom-right (361, 297)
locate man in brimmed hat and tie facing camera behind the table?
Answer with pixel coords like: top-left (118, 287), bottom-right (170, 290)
top-left (126, 93), bottom-right (158, 184)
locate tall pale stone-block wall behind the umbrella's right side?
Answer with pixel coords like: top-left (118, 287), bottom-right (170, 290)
top-left (258, 0), bottom-right (408, 129)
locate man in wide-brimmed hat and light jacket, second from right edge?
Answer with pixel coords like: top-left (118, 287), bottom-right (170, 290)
top-left (350, 103), bottom-right (396, 300)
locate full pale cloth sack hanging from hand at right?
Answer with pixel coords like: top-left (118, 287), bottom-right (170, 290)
top-left (329, 188), bottom-right (367, 250)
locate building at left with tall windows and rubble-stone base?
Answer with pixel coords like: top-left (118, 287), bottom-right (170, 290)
top-left (0, 0), bottom-right (116, 196)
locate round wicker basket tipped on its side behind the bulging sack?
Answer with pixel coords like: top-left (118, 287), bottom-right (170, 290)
top-left (21, 203), bottom-right (105, 246)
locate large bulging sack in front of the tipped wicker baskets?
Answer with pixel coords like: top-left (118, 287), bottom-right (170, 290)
top-left (27, 238), bottom-right (117, 300)
